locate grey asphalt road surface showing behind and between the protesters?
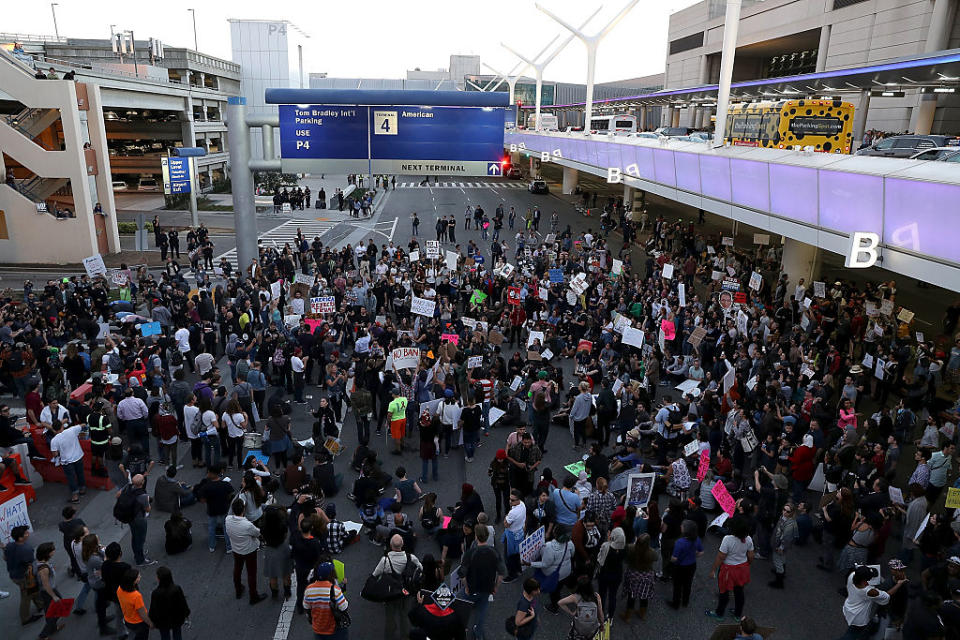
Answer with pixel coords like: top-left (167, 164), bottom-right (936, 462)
top-left (0, 181), bottom-right (845, 640)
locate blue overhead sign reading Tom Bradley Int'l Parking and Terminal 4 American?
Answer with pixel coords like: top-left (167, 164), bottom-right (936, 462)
top-left (279, 104), bottom-right (504, 176)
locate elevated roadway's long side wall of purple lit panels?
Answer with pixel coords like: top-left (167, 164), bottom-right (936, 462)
top-left (504, 131), bottom-right (960, 291)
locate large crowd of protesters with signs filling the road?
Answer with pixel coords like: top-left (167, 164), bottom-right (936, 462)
top-left (0, 190), bottom-right (960, 640)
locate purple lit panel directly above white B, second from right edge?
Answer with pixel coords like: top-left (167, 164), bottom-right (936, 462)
top-left (819, 170), bottom-right (883, 233)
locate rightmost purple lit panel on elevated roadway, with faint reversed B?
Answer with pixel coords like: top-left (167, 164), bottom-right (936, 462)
top-left (883, 178), bottom-right (960, 262)
